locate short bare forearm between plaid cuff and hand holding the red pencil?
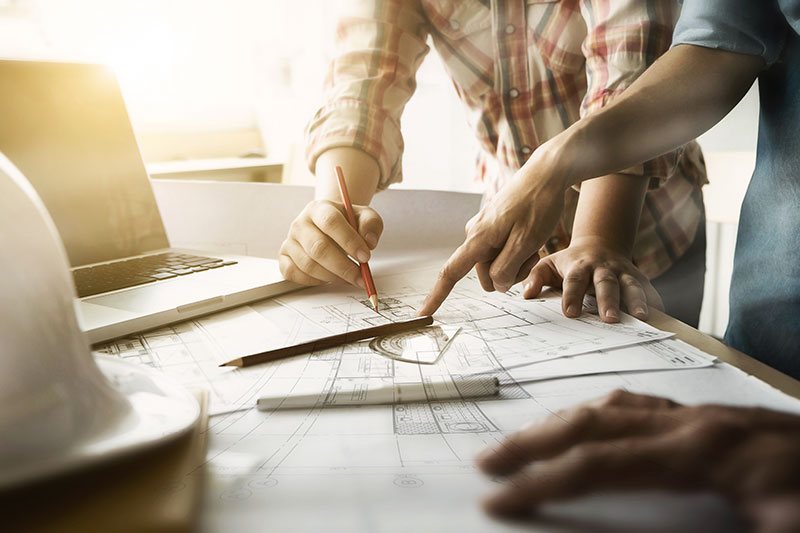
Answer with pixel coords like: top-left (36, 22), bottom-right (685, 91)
top-left (314, 147), bottom-right (380, 205)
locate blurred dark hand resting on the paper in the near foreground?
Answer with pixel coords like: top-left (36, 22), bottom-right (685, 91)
top-left (477, 390), bottom-right (800, 532)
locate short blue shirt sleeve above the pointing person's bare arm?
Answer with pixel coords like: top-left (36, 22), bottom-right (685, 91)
top-left (672, 0), bottom-right (787, 65)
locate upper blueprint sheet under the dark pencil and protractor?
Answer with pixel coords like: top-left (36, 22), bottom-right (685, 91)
top-left (100, 270), bottom-right (680, 414)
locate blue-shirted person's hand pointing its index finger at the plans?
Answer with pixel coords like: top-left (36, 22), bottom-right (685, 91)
top-left (419, 153), bottom-right (566, 316)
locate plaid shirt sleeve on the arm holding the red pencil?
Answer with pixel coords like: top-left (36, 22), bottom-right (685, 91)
top-left (306, 0), bottom-right (429, 189)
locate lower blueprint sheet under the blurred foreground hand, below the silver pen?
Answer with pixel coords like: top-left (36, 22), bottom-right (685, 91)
top-left (186, 362), bottom-right (800, 532)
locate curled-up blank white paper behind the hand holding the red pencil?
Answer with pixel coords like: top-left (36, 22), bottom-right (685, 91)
top-left (153, 180), bottom-right (481, 261)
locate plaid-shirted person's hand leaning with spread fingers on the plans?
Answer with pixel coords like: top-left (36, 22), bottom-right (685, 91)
top-left (522, 237), bottom-right (664, 323)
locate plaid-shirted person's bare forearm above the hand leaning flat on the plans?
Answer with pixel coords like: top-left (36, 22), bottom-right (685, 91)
top-left (572, 174), bottom-right (647, 257)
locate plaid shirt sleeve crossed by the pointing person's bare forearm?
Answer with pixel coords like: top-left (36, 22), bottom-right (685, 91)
top-left (581, 0), bottom-right (683, 182)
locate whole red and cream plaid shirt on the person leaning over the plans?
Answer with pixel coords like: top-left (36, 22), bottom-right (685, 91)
top-left (307, 0), bottom-right (706, 278)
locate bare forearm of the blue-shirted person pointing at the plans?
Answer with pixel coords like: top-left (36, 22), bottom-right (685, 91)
top-left (544, 45), bottom-right (764, 186)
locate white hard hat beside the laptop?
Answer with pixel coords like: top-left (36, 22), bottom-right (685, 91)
top-left (0, 154), bottom-right (199, 488)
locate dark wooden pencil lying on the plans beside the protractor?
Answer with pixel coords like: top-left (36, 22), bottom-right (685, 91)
top-left (219, 316), bottom-right (433, 367)
